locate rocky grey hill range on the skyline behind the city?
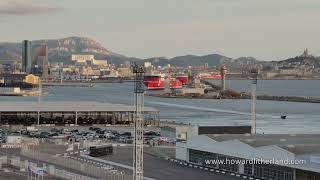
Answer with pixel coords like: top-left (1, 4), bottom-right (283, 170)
top-left (0, 36), bottom-right (257, 67)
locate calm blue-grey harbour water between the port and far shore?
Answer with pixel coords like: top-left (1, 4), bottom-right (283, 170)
top-left (0, 80), bottom-right (320, 133)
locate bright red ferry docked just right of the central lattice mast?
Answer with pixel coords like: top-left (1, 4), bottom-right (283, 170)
top-left (143, 75), bottom-right (183, 90)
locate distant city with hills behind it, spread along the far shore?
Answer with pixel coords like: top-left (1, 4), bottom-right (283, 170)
top-left (0, 37), bottom-right (320, 95)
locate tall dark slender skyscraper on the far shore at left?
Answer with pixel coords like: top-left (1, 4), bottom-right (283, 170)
top-left (22, 40), bottom-right (32, 73)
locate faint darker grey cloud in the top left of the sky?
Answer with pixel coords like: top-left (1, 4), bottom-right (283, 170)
top-left (0, 0), bottom-right (63, 15)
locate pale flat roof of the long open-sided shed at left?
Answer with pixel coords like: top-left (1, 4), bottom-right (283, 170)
top-left (0, 101), bottom-right (159, 112)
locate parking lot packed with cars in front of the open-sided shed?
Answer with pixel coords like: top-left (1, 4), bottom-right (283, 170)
top-left (0, 126), bottom-right (175, 145)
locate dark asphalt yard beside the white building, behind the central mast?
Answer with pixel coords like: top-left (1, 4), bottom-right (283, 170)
top-left (97, 147), bottom-right (242, 180)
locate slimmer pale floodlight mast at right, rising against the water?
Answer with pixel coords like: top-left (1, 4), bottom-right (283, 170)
top-left (250, 69), bottom-right (258, 134)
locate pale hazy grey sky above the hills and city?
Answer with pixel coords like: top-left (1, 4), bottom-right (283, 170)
top-left (0, 0), bottom-right (320, 60)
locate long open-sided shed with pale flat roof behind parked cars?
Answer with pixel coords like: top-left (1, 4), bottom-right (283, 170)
top-left (0, 101), bottom-right (159, 125)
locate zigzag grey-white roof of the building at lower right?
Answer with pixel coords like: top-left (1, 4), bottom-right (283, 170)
top-left (186, 134), bottom-right (320, 173)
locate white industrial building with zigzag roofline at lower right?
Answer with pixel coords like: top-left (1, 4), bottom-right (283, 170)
top-left (176, 134), bottom-right (320, 180)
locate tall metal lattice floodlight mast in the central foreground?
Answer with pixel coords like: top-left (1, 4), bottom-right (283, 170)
top-left (133, 64), bottom-right (145, 180)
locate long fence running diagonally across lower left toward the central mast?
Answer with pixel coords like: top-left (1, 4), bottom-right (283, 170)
top-left (21, 149), bottom-right (133, 180)
